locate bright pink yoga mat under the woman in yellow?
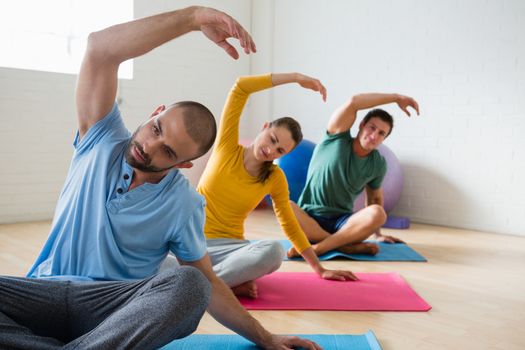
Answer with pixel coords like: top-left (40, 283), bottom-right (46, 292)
top-left (239, 272), bottom-right (431, 311)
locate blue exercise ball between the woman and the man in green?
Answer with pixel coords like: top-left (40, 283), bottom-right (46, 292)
top-left (277, 140), bottom-right (315, 202)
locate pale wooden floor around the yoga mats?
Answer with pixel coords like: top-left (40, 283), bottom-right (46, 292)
top-left (0, 210), bottom-right (525, 350)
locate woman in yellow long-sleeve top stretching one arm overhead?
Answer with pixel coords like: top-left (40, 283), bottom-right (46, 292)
top-left (197, 73), bottom-right (356, 298)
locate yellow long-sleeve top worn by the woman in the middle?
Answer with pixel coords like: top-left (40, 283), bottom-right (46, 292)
top-left (197, 74), bottom-right (310, 252)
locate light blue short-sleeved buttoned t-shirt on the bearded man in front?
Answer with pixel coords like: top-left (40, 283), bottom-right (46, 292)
top-left (27, 104), bottom-right (206, 280)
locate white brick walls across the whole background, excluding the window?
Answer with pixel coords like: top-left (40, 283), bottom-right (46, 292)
top-left (0, 0), bottom-right (525, 235)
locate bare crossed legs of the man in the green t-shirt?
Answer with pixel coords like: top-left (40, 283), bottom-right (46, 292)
top-left (288, 202), bottom-right (386, 257)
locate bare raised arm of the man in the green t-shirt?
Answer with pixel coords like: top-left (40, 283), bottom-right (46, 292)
top-left (327, 93), bottom-right (419, 134)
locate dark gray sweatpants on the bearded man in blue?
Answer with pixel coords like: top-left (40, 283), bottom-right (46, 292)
top-left (0, 266), bottom-right (211, 349)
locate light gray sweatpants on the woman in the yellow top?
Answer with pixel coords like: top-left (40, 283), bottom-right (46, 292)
top-left (206, 238), bottom-right (284, 287)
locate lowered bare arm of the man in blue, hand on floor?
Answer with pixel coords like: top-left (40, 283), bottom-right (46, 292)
top-left (182, 255), bottom-right (321, 350)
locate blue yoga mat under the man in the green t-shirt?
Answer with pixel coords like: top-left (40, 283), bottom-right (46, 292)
top-left (279, 239), bottom-right (427, 261)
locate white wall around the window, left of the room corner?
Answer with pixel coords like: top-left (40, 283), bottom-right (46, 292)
top-left (0, 0), bottom-right (251, 222)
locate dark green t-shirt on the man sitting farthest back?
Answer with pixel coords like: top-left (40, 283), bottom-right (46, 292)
top-left (297, 131), bottom-right (386, 217)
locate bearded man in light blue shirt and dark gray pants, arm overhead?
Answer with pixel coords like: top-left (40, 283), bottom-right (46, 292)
top-left (0, 7), bottom-right (318, 349)
